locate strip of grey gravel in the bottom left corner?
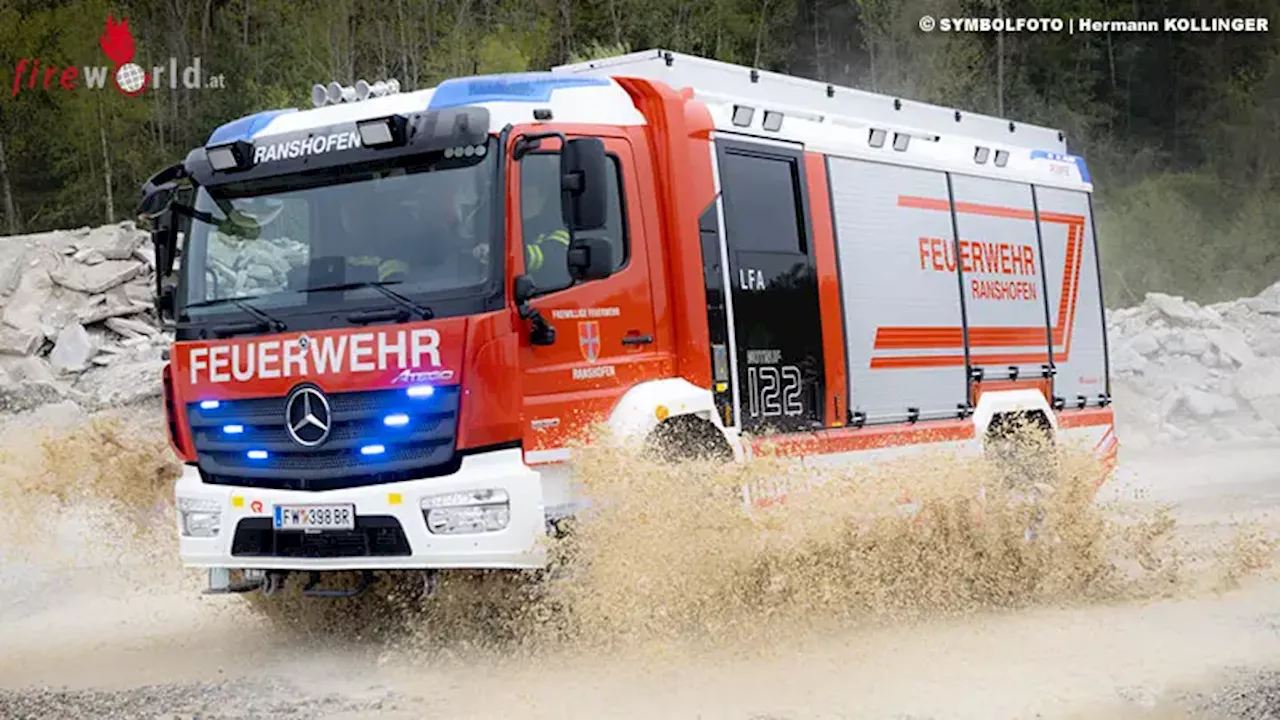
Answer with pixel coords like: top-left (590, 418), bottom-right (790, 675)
top-left (0, 680), bottom-right (397, 720)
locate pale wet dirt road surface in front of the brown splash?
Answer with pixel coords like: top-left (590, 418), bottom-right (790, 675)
top-left (0, 412), bottom-right (1280, 720)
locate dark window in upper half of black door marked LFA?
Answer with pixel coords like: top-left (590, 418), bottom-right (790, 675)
top-left (721, 152), bottom-right (808, 255)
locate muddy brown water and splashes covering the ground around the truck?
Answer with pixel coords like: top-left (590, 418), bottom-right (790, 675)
top-left (0, 411), bottom-right (1280, 720)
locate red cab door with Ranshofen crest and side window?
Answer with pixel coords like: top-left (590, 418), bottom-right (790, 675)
top-left (508, 127), bottom-right (662, 453)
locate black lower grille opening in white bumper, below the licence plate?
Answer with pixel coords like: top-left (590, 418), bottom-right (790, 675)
top-left (232, 515), bottom-right (411, 557)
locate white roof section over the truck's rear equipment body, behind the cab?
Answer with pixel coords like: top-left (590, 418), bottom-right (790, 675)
top-left (552, 50), bottom-right (1092, 190)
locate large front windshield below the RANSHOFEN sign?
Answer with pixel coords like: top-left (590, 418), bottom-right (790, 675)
top-left (182, 139), bottom-right (494, 315)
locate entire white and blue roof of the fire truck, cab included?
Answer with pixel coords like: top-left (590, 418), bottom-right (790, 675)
top-left (206, 49), bottom-right (1092, 190)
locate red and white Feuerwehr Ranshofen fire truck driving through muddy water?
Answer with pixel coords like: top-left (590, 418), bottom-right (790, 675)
top-left (140, 50), bottom-right (1117, 593)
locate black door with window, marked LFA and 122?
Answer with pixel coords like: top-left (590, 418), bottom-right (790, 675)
top-left (717, 140), bottom-right (824, 434)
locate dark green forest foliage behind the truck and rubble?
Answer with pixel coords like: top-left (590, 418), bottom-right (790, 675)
top-left (0, 0), bottom-right (1280, 305)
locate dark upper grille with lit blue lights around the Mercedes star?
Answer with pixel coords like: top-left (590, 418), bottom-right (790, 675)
top-left (187, 386), bottom-right (461, 491)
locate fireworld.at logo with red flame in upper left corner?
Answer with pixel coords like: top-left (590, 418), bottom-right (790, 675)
top-left (10, 15), bottom-right (227, 97)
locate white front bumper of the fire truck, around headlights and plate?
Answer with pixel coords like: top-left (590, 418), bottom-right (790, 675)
top-left (174, 448), bottom-right (547, 570)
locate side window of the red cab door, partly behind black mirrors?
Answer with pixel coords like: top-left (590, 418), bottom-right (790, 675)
top-left (520, 152), bottom-right (628, 295)
